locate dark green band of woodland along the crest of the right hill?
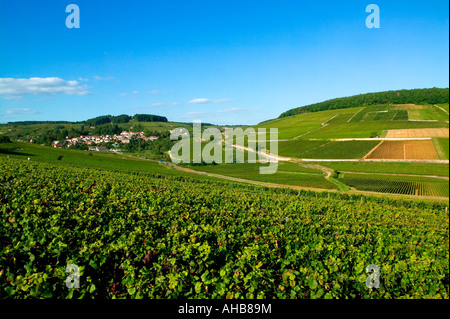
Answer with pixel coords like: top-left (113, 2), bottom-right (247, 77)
top-left (278, 88), bottom-right (449, 118)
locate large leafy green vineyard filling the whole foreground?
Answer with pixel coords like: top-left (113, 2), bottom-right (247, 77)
top-left (0, 158), bottom-right (449, 298)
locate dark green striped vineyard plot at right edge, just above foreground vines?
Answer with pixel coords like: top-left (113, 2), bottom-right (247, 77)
top-left (342, 173), bottom-right (449, 197)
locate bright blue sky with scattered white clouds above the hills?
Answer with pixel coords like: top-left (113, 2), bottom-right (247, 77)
top-left (0, 0), bottom-right (449, 124)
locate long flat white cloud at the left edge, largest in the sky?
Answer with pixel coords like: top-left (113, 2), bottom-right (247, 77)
top-left (0, 77), bottom-right (89, 98)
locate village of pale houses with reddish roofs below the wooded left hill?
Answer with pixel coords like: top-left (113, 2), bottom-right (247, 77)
top-left (52, 131), bottom-right (158, 151)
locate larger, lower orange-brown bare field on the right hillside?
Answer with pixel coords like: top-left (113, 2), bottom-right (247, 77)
top-left (367, 140), bottom-right (439, 160)
